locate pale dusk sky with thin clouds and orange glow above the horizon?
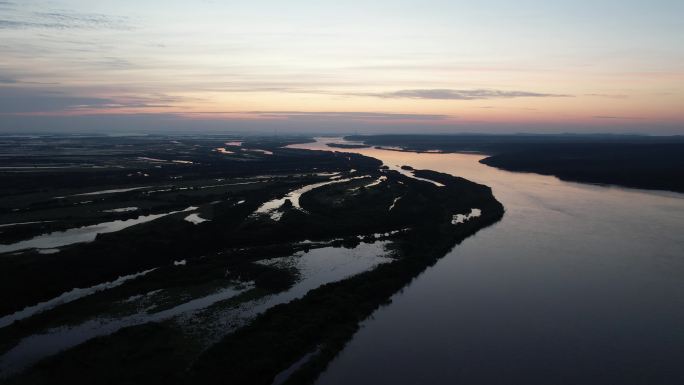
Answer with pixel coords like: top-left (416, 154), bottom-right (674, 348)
top-left (0, 0), bottom-right (684, 135)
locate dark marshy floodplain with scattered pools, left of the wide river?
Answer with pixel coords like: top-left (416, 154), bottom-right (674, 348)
top-left (0, 137), bottom-right (503, 384)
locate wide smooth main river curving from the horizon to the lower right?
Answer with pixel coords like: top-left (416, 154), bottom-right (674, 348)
top-left (292, 138), bottom-right (684, 385)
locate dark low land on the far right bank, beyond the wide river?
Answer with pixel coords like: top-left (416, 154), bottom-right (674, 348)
top-left (348, 135), bottom-right (684, 192)
